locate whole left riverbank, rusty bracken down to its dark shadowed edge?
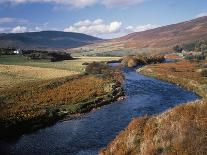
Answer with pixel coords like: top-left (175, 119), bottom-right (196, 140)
top-left (0, 63), bottom-right (124, 137)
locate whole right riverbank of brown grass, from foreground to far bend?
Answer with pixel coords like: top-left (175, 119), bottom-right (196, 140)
top-left (100, 61), bottom-right (207, 155)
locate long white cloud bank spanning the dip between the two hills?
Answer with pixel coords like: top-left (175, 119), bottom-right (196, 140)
top-left (64, 19), bottom-right (159, 38)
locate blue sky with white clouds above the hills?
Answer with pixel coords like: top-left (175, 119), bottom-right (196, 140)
top-left (0, 0), bottom-right (207, 38)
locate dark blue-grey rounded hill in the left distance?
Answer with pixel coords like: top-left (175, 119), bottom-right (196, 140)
top-left (0, 31), bottom-right (101, 49)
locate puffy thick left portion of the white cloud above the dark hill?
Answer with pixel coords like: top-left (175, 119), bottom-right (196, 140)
top-left (64, 19), bottom-right (122, 36)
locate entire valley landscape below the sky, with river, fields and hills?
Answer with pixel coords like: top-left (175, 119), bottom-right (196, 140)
top-left (0, 13), bottom-right (207, 155)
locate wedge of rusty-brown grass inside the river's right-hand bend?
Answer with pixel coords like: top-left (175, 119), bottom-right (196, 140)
top-left (140, 61), bottom-right (207, 97)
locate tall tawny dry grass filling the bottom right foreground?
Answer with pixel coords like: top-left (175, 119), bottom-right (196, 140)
top-left (100, 100), bottom-right (207, 155)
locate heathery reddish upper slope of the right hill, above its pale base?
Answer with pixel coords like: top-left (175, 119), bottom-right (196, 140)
top-left (115, 17), bottom-right (207, 48)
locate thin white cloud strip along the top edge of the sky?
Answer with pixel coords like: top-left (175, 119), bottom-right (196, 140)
top-left (0, 0), bottom-right (146, 8)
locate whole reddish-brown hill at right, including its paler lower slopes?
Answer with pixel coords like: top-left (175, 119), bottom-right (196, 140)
top-left (75, 17), bottom-right (207, 54)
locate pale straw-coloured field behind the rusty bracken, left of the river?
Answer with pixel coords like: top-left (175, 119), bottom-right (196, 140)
top-left (0, 65), bottom-right (78, 91)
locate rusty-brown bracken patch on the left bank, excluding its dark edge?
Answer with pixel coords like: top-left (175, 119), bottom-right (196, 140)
top-left (0, 76), bottom-right (109, 119)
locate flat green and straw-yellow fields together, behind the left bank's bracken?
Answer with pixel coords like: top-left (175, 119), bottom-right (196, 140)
top-left (0, 55), bottom-right (119, 90)
